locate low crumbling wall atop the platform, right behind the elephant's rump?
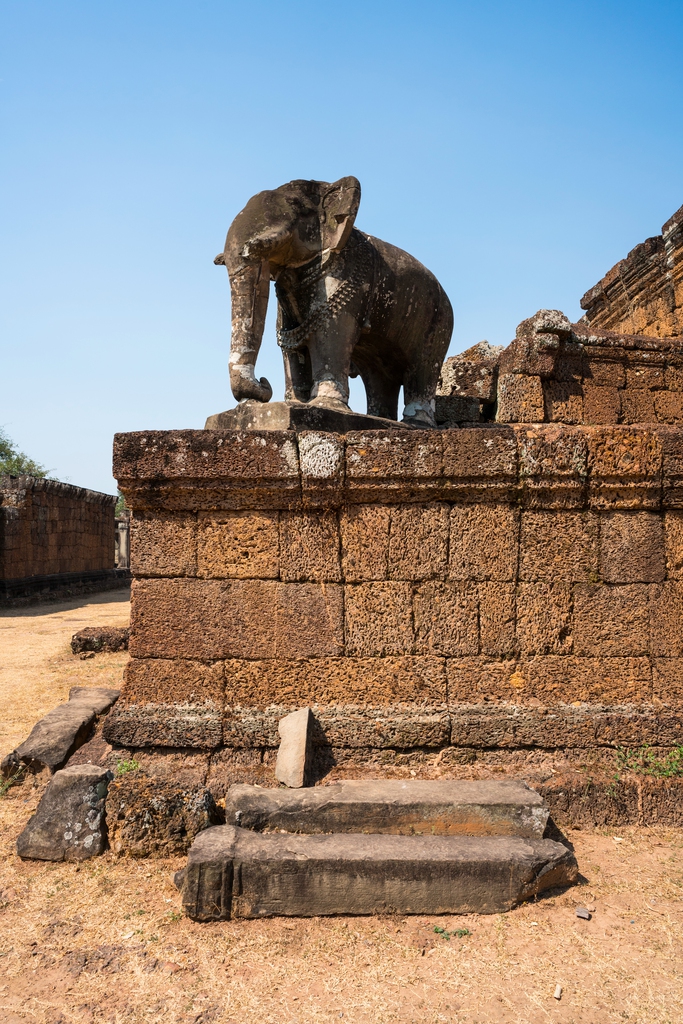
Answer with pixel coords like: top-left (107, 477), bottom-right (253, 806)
top-left (436, 309), bottom-right (683, 427)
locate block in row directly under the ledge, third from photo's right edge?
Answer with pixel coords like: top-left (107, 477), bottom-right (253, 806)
top-left (519, 510), bottom-right (599, 583)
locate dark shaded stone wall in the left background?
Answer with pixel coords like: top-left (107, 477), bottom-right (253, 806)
top-left (0, 476), bottom-right (116, 593)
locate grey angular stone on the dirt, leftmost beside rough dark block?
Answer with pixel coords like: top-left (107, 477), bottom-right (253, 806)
top-left (16, 765), bottom-right (112, 861)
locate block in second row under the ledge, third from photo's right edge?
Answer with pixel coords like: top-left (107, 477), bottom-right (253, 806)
top-left (517, 583), bottom-right (572, 655)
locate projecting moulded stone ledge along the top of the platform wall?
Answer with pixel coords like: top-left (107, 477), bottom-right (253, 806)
top-left (114, 423), bottom-right (683, 512)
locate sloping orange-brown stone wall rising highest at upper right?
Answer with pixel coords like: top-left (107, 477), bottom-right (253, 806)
top-left (581, 207), bottom-right (683, 338)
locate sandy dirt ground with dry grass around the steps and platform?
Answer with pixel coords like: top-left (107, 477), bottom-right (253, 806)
top-left (0, 592), bottom-right (683, 1024)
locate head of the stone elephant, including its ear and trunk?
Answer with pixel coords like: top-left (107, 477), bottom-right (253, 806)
top-left (214, 177), bottom-right (360, 401)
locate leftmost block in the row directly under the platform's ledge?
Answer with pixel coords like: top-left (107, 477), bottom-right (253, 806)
top-left (130, 511), bottom-right (197, 577)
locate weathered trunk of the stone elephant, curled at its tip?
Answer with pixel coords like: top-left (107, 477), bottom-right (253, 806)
top-left (226, 260), bottom-right (272, 401)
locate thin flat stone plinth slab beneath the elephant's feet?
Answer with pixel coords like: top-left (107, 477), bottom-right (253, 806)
top-left (204, 399), bottom-right (413, 434)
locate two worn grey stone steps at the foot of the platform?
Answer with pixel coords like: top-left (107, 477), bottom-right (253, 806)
top-left (176, 779), bottom-right (578, 921)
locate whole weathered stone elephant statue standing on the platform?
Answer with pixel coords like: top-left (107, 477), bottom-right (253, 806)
top-left (214, 177), bottom-right (453, 427)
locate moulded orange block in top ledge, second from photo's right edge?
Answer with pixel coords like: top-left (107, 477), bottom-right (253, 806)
top-left (587, 427), bottom-right (666, 508)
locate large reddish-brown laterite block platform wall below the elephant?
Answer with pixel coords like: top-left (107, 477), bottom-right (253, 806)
top-left (106, 424), bottom-right (683, 765)
